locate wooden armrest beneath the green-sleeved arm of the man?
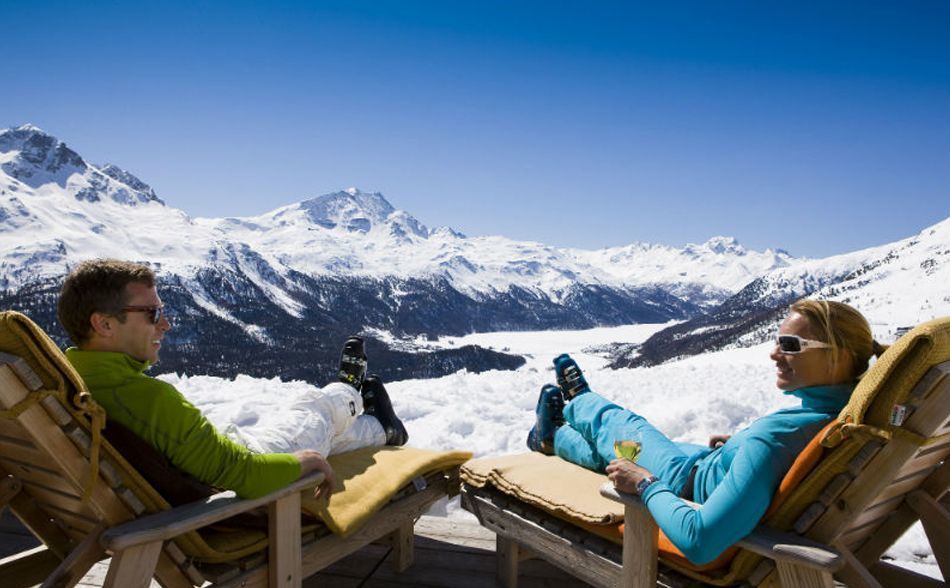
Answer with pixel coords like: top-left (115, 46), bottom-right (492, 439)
top-left (99, 472), bottom-right (323, 551)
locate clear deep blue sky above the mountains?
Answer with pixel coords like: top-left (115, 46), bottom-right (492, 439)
top-left (0, 0), bottom-right (950, 257)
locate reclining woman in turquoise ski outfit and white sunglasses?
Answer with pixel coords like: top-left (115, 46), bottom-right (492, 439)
top-left (528, 300), bottom-right (884, 564)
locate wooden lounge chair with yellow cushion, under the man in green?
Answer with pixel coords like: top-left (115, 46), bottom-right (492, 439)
top-left (0, 312), bottom-right (466, 588)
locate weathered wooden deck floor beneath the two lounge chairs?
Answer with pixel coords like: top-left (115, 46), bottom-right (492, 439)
top-left (0, 513), bottom-right (587, 588)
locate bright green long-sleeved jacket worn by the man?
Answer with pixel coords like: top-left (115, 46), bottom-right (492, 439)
top-left (66, 347), bottom-right (300, 498)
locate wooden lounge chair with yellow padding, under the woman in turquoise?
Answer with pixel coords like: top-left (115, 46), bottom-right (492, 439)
top-left (462, 318), bottom-right (950, 587)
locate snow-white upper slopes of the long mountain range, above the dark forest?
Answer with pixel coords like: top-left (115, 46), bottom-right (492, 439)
top-left (0, 125), bottom-right (793, 304)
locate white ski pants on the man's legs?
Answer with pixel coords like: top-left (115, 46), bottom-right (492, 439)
top-left (225, 382), bottom-right (386, 456)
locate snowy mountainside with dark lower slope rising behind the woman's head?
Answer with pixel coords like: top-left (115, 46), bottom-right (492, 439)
top-left (612, 218), bottom-right (950, 367)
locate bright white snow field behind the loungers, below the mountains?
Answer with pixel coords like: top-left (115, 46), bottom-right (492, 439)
top-left (158, 325), bottom-right (941, 578)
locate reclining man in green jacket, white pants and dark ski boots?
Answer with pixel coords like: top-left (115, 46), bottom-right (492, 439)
top-left (58, 259), bottom-right (408, 498)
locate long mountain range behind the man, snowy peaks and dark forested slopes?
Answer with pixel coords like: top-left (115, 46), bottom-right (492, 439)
top-left (0, 125), bottom-right (944, 380)
